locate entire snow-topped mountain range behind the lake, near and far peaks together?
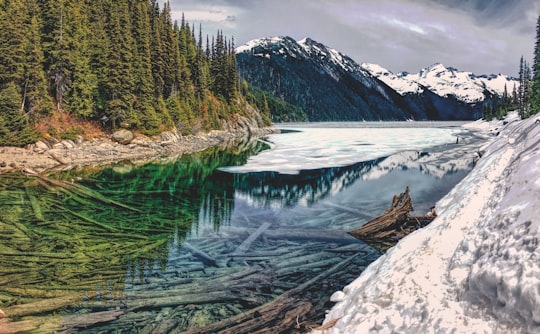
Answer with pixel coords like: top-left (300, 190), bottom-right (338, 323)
top-left (236, 37), bottom-right (511, 121)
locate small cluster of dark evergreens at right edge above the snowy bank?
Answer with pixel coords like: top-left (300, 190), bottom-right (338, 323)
top-left (484, 16), bottom-right (540, 120)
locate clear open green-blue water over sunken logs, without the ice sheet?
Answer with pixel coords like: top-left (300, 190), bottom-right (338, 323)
top-left (0, 132), bottom-right (478, 333)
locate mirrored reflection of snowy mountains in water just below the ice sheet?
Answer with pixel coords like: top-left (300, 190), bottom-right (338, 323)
top-left (230, 151), bottom-right (474, 207)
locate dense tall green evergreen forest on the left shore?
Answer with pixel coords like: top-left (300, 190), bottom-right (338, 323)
top-left (0, 0), bottom-right (266, 146)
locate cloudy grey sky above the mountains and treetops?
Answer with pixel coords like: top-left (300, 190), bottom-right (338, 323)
top-left (162, 0), bottom-right (540, 76)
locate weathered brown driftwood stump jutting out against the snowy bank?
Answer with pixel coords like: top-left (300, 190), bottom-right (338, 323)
top-left (349, 187), bottom-right (437, 251)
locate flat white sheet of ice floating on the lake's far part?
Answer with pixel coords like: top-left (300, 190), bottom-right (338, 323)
top-left (222, 122), bottom-right (464, 174)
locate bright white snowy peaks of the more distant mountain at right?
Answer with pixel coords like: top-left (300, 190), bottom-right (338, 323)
top-left (362, 63), bottom-right (519, 103)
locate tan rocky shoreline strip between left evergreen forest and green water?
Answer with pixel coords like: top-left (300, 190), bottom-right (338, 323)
top-left (0, 119), bottom-right (279, 174)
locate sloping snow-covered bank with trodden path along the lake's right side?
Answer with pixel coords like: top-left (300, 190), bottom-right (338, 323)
top-left (315, 116), bottom-right (540, 333)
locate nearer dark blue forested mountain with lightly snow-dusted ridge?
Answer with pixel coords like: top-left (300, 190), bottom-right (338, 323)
top-left (237, 37), bottom-right (427, 121)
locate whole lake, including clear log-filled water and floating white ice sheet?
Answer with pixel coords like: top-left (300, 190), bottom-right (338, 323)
top-left (0, 122), bottom-right (483, 333)
